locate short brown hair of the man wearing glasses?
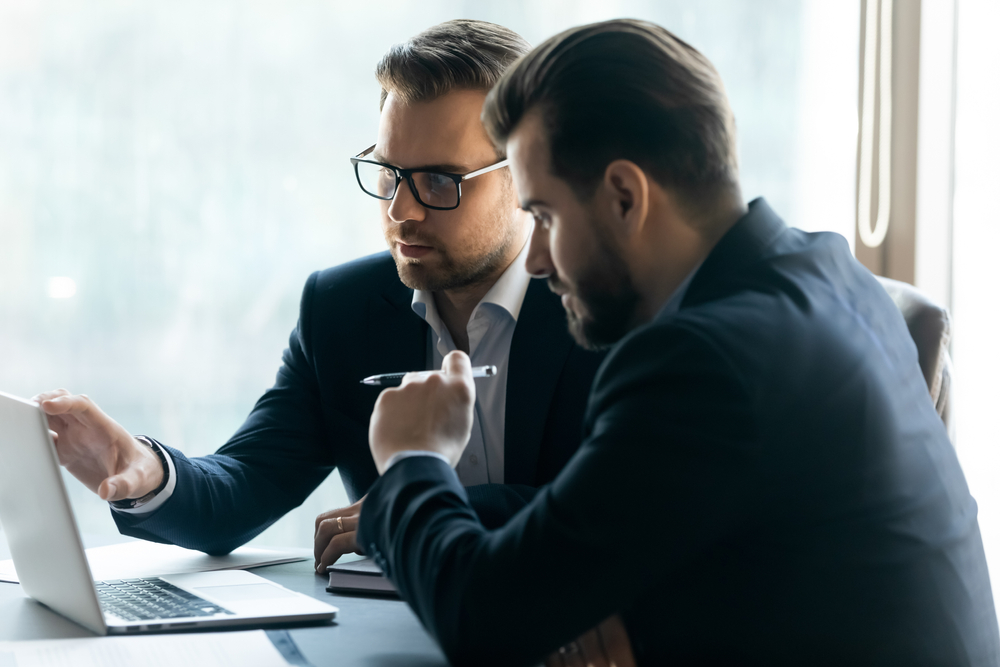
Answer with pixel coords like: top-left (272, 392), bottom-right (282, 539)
top-left (375, 19), bottom-right (531, 109)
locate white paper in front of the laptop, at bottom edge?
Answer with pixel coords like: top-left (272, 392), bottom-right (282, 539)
top-left (0, 630), bottom-right (288, 667)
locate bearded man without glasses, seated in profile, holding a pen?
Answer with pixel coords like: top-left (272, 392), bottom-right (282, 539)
top-left (359, 20), bottom-right (1000, 667)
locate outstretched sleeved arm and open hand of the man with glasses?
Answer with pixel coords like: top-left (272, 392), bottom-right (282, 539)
top-left (42, 274), bottom-right (344, 554)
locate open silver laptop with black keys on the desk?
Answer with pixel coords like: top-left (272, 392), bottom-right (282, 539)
top-left (0, 392), bottom-right (337, 635)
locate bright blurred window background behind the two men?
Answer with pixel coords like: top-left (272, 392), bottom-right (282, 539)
top-left (0, 0), bottom-right (1000, 604)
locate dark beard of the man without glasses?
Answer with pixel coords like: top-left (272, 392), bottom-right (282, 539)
top-left (549, 218), bottom-right (641, 350)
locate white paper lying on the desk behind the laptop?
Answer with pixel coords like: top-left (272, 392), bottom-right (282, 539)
top-left (0, 540), bottom-right (312, 584)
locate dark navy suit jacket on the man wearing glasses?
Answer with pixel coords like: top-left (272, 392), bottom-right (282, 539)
top-left (112, 252), bottom-right (603, 554)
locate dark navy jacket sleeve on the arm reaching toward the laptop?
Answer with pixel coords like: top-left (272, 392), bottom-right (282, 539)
top-left (112, 274), bottom-right (344, 554)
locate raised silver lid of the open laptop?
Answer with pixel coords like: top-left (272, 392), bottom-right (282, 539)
top-left (0, 392), bottom-right (107, 635)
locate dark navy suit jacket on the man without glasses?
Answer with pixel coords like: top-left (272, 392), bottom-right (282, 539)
top-left (359, 200), bottom-right (998, 665)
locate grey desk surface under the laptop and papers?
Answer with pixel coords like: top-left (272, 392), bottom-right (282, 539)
top-left (0, 532), bottom-right (447, 667)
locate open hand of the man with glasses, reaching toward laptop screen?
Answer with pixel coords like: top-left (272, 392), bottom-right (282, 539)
top-left (32, 389), bottom-right (163, 501)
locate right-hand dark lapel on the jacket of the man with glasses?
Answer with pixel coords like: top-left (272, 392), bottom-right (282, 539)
top-left (504, 280), bottom-right (574, 486)
